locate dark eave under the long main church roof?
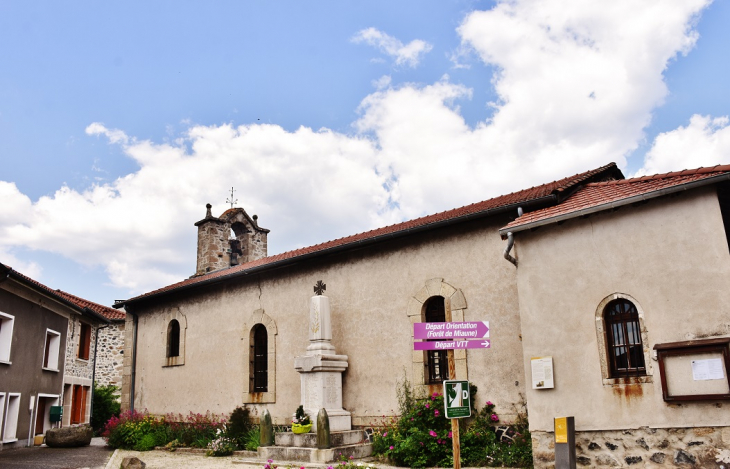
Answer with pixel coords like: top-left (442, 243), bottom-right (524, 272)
top-left (114, 194), bottom-right (557, 309)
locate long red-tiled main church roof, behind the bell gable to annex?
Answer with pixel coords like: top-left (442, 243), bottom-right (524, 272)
top-left (114, 163), bottom-right (624, 308)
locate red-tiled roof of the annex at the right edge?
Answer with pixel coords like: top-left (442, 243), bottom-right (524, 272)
top-left (499, 165), bottom-right (730, 237)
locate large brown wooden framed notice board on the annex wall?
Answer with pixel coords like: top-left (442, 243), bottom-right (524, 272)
top-left (654, 337), bottom-right (730, 402)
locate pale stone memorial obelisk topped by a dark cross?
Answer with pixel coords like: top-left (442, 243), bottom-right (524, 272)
top-left (294, 280), bottom-right (352, 432)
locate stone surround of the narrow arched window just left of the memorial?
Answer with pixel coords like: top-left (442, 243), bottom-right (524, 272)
top-left (241, 309), bottom-right (279, 404)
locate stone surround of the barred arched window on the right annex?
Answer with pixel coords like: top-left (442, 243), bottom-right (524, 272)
top-left (595, 292), bottom-right (654, 386)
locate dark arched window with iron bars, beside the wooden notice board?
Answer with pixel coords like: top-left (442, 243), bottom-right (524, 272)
top-left (603, 298), bottom-right (646, 378)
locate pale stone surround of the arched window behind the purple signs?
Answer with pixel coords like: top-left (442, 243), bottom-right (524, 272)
top-left (406, 278), bottom-right (469, 393)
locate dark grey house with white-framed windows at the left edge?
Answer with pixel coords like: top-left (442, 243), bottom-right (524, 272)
top-left (0, 264), bottom-right (108, 449)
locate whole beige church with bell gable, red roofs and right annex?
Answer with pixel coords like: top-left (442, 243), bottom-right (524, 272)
top-left (115, 164), bottom-right (730, 467)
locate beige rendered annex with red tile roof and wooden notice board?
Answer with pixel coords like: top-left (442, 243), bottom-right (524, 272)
top-left (500, 165), bottom-right (730, 467)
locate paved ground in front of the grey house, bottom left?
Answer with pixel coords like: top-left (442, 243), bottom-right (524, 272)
top-left (0, 438), bottom-right (114, 469)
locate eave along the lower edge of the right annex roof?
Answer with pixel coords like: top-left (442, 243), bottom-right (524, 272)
top-left (499, 173), bottom-right (730, 238)
